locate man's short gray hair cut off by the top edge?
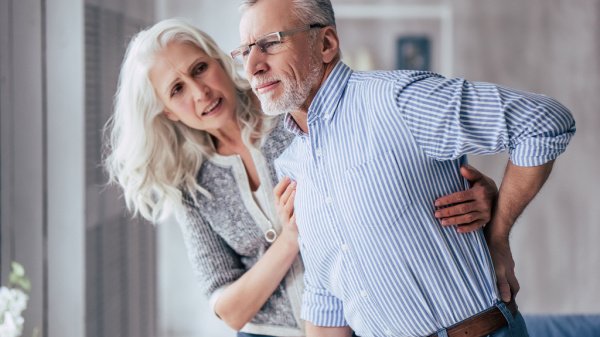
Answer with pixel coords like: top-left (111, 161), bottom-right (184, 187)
top-left (240, 0), bottom-right (335, 27)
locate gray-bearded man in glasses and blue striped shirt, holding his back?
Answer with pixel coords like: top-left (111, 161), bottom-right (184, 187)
top-left (232, 0), bottom-right (575, 337)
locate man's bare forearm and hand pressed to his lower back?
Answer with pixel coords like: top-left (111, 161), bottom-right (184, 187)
top-left (485, 160), bottom-right (554, 302)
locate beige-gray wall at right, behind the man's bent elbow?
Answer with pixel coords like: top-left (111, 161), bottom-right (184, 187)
top-left (453, 0), bottom-right (600, 313)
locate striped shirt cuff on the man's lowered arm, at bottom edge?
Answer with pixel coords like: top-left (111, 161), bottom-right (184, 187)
top-left (300, 286), bottom-right (348, 327)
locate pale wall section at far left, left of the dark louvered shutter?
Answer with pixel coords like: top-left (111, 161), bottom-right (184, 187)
top-left (0, 0), bottom-right (85, 337)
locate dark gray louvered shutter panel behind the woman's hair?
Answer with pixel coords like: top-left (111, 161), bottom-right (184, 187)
top-left (82, 0), bottom-right (158, 337)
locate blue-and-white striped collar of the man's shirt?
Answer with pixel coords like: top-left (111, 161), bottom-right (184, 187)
top-left (284, 61), bottom-right (353, 136)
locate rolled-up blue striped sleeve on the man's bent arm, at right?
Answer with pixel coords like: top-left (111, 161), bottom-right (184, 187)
top-left (395, 73), bottom-right (575, 166)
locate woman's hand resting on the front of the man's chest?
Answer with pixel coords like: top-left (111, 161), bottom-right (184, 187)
top-left (273, 177), bottom-right (298, 241)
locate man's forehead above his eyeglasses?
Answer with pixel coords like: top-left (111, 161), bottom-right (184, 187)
top-left (240, 0), bottom-right (300, 44)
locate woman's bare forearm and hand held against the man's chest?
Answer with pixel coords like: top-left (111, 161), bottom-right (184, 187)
top-left (215, 178), bottom-right (299, 330)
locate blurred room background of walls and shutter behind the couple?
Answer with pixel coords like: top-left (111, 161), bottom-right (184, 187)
top-left (0, 0), bottom-right (600, 337)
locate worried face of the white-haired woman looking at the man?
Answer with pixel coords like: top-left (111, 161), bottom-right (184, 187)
top-left (150, 42), bottom-right (237, 133)
